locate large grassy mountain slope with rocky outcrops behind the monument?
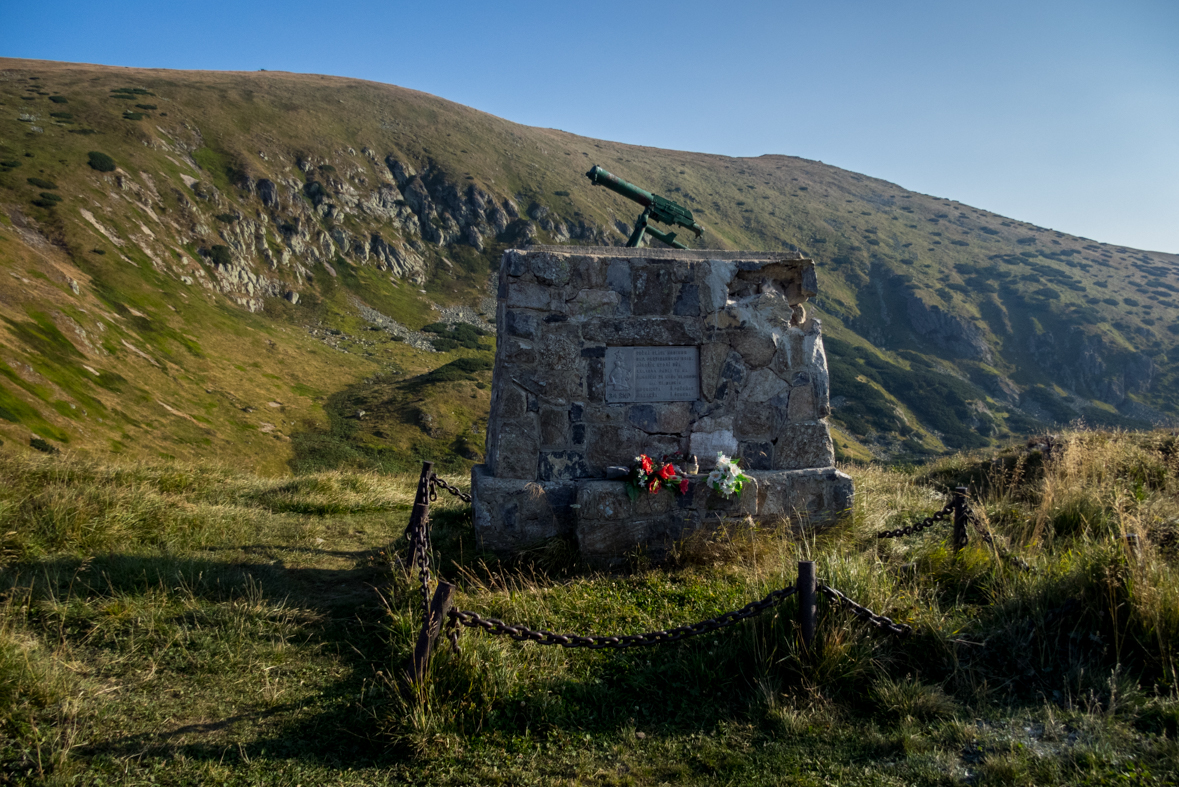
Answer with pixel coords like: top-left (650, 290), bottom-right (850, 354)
top-left (0, 59), bottom-right (1179, 471)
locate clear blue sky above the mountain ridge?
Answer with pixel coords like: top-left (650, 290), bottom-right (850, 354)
top-left (9, 0), bottom-right (1179, 253)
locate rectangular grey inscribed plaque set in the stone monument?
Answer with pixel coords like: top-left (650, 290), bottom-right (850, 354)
top-left (605, 348), bottom-right (700, 402)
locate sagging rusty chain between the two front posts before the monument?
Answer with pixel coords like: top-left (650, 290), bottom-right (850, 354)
top-left (448, 586), bottom-right (797, 653)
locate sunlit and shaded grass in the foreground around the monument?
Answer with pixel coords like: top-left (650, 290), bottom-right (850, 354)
top-left (0, 432), bottom-right (1179, 787)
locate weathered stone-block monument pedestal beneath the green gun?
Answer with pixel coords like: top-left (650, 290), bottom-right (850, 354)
top-left (472, 246), bottom-right (852, 563)
